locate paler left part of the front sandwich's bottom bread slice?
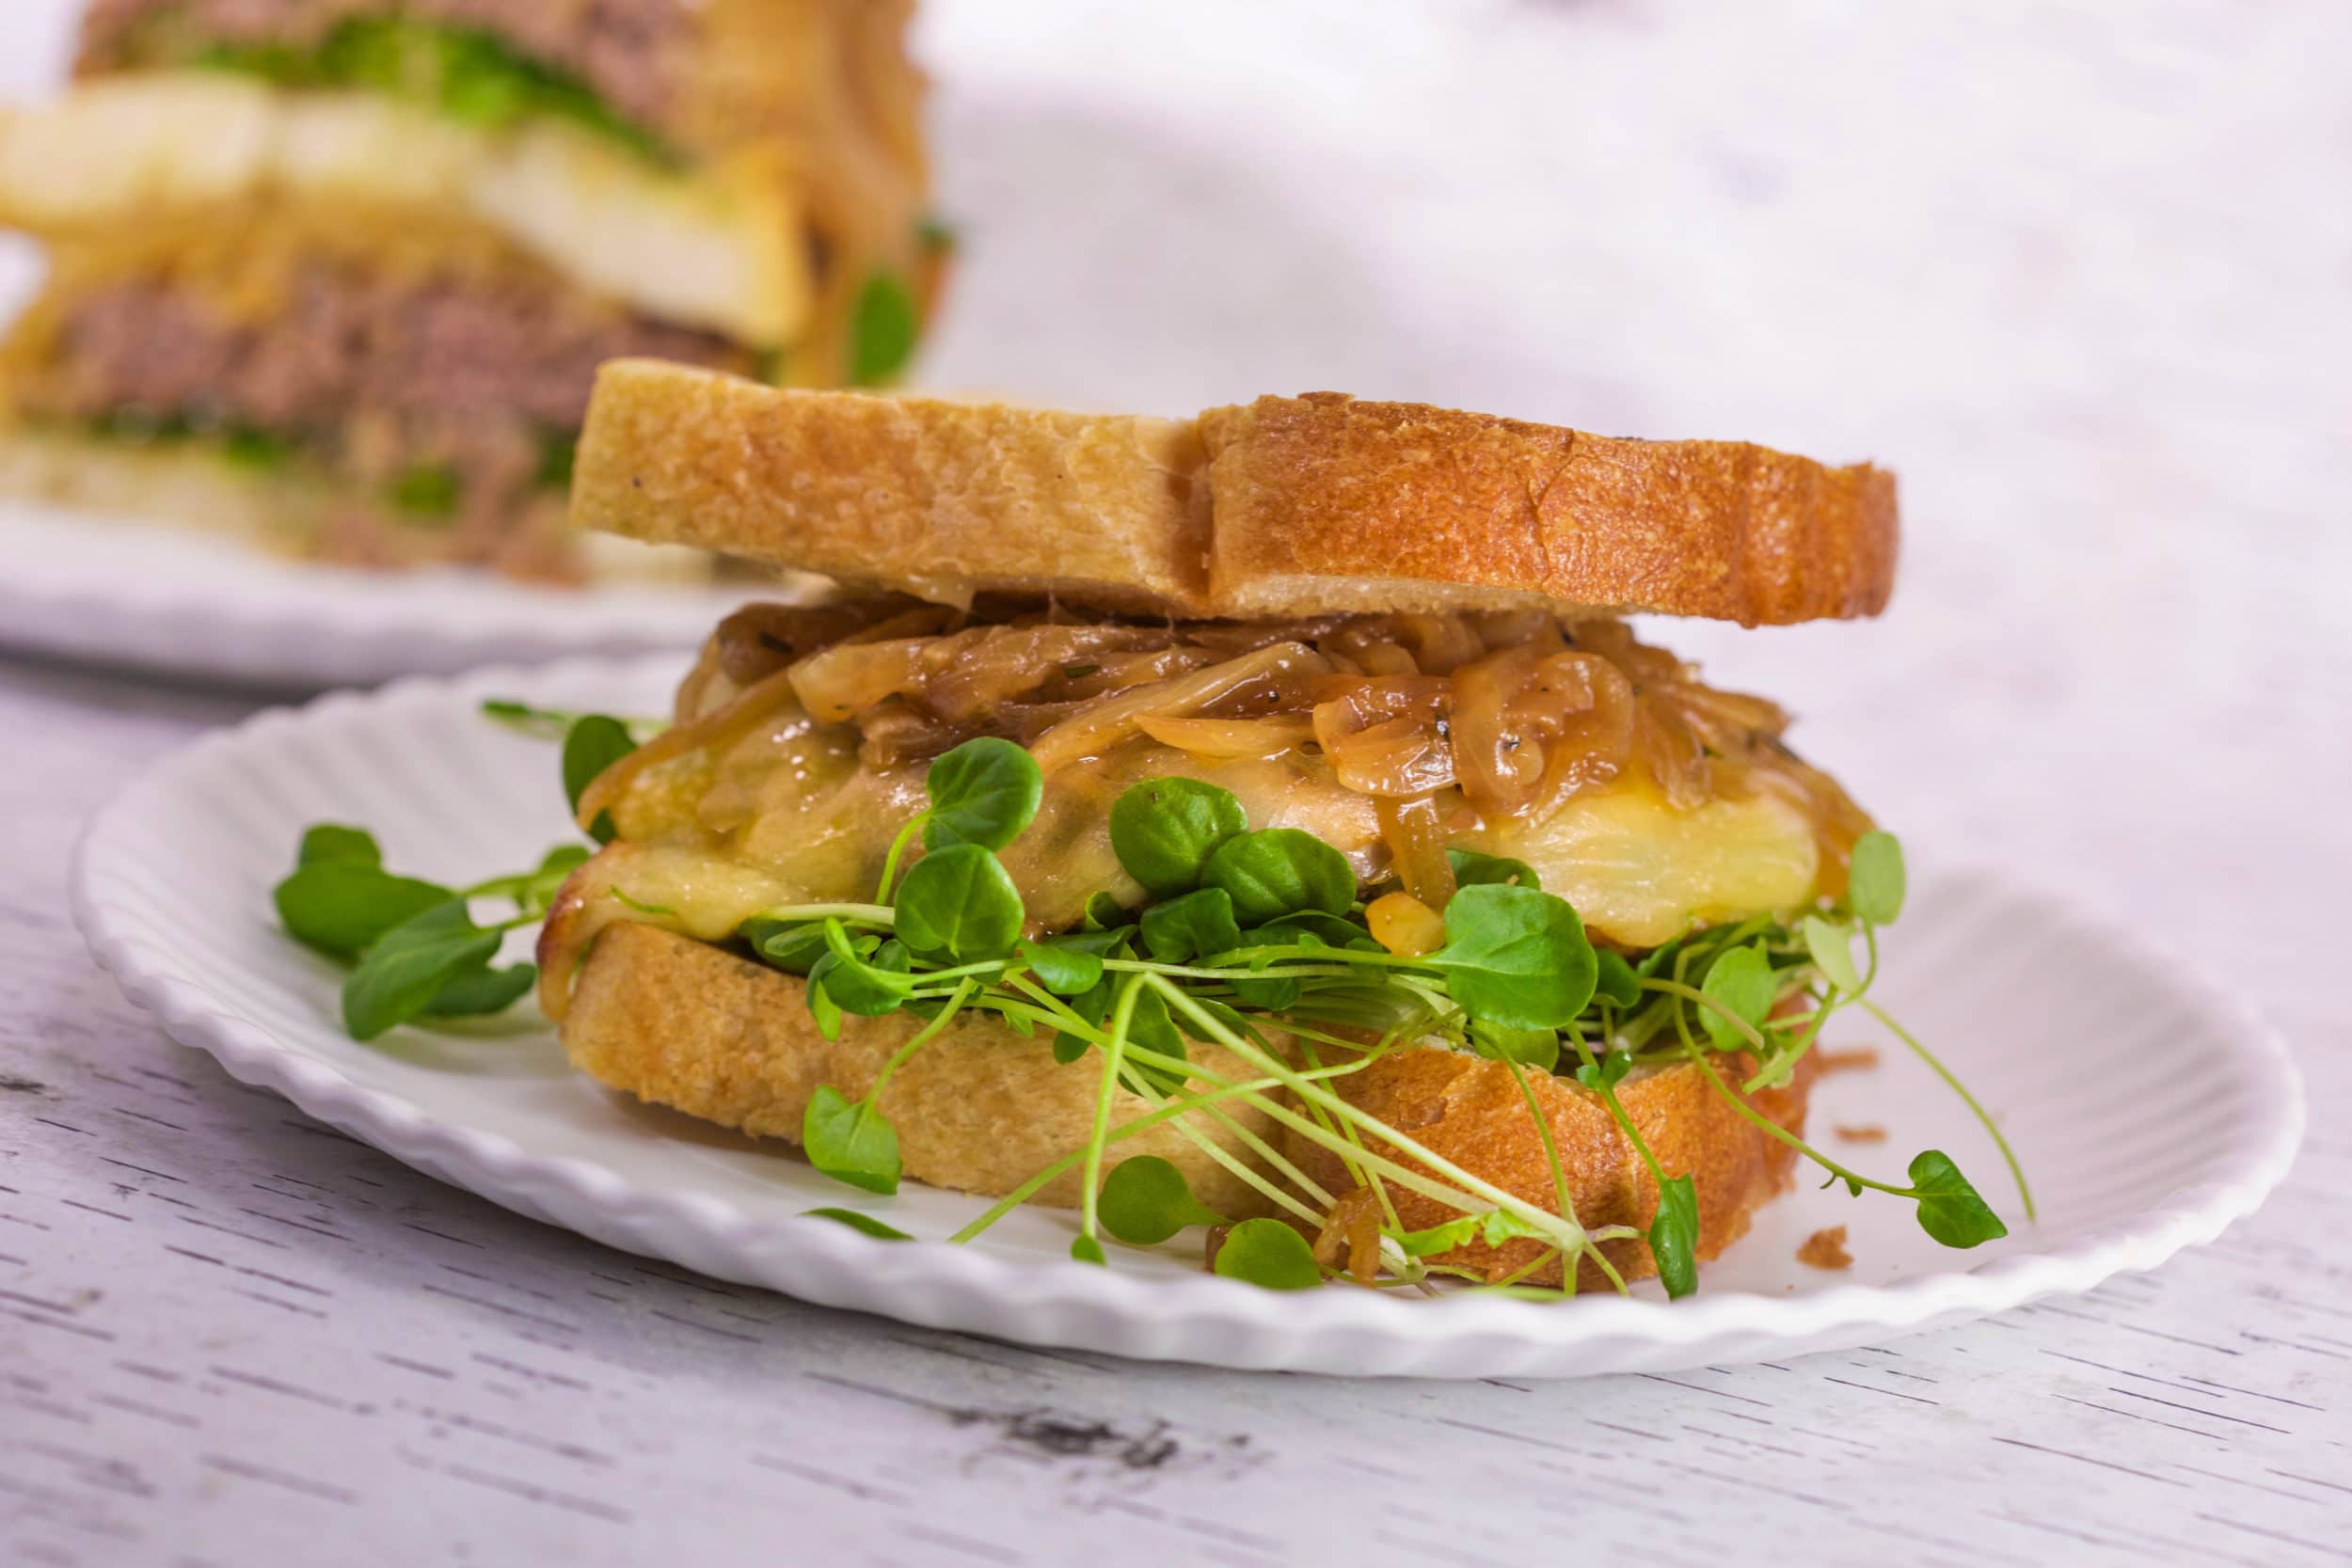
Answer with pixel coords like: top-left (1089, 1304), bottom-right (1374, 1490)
top-left (563, 924), bottom-right (1275, 1218)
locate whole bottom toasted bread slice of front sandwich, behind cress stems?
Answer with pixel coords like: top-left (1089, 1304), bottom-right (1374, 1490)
top-left (563, 924), bottom-right (1811, 1289)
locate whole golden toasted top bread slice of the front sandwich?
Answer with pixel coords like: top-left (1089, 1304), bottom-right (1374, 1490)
top-left (572, 359), bottom-right (1899, 626)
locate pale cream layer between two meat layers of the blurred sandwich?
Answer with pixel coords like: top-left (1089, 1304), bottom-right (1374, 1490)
top-left (0, 71), bottom-right (814, 348)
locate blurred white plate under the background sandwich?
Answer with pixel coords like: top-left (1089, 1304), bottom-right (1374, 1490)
top-left (0, 500), bottom-right (753, 691)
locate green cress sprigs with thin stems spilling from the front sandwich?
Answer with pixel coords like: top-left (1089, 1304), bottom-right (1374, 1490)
top-left (278, 703), bottom-right (2032, 1298)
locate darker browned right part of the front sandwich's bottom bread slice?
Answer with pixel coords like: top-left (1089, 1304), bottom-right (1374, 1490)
top-left (1287, 1051), bottom-right (1814, 1291)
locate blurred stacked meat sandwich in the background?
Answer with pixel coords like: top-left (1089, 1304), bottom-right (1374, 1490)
top-left (0, 0), bottom-right (948, 580)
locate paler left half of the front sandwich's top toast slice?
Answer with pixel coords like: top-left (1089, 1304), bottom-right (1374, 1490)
top-left (572, 359), bottom-right (1207, 611)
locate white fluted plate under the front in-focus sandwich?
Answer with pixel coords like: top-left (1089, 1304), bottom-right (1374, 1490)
top-left (75, 658), bottom-right (2303, 1375)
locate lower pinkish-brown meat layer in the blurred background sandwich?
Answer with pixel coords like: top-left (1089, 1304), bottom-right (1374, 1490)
top-left (26, 265), bottom-right (746, 470)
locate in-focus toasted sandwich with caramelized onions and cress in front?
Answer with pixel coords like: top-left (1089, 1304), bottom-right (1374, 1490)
top-left (282, 362), bottom-right (2007, 1295)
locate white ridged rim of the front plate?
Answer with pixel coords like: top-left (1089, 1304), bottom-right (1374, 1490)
top-left (69, 654), bottom-right (2308, 1375)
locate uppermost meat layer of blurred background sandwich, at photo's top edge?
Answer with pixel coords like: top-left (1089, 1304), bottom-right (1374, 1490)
top-left (80, 0), bottom-right (694, 127)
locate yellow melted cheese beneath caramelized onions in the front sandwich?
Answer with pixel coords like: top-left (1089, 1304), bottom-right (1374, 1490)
top-left (548, 690), bottom-right (1820, 974)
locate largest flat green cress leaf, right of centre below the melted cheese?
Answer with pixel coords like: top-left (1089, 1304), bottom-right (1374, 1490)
top-left (1428, 881), bottom-right (1599, 1030)
